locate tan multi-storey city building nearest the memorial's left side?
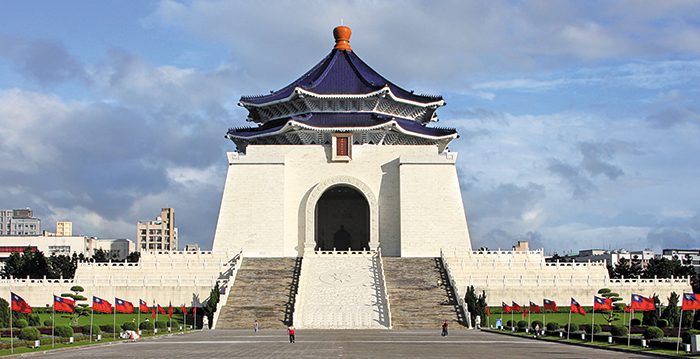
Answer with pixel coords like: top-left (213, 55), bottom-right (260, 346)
top-left (136, 207), bottom-right (177, 252)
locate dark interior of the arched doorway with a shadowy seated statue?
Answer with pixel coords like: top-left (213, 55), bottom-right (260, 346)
top-left (316, 186), bottom-right (369, 251)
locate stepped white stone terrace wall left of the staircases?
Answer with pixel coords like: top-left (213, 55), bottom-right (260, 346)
top-left (0, 252), bottom-right (238, 307)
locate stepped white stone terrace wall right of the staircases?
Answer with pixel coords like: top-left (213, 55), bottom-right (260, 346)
top-left (445, 251), bottom-right (692, 307)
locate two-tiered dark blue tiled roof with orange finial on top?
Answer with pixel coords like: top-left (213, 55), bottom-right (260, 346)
top-left (226, 26), bottom-right (457, 152)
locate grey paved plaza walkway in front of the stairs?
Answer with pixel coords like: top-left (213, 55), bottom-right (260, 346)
top-left (24, 328), bottom-right (648, 359)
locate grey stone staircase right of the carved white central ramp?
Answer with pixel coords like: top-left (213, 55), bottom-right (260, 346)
top-left (382, 257), bottom-right (465, 330)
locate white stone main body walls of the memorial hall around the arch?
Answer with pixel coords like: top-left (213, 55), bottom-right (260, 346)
top-left (212, 145), bottom-right (471, 257)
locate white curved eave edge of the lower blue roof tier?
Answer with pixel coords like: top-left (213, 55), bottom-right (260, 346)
top-left (226, 120), bottom-right (458, 142)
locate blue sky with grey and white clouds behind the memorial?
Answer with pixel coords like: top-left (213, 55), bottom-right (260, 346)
top-left (0, 0), bottom-right (700, 254)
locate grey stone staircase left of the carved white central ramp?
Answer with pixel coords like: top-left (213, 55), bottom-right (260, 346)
top-left (216, 257), bottom-right (301, 330)
